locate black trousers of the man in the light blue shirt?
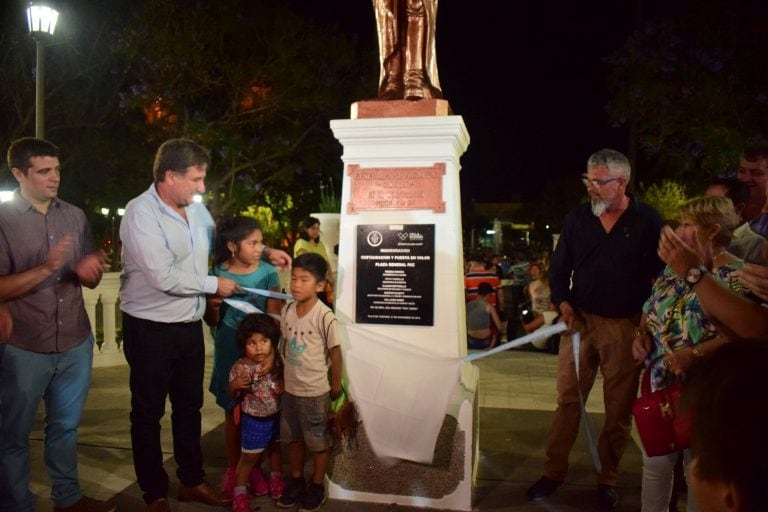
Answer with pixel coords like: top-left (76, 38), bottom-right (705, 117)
top-left (123, 313), bottom-right (205, 503)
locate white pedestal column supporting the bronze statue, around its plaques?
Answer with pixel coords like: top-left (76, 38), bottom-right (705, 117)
top-left (328, 116), bottom-right (479, 511)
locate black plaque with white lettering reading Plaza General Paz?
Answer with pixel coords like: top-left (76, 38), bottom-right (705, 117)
top-left (355, 224), bottom-right (435, 325)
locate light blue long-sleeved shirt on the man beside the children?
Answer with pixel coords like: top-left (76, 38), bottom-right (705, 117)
top-left (120, 184), bottom-right (218, 323)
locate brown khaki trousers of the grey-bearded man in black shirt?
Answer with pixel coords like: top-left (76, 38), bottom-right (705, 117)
top-left (544, 310), bottom-right (640, 486)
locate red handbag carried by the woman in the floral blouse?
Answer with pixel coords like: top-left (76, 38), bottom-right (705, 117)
top-left (632, 370), bottom-right (692, 457)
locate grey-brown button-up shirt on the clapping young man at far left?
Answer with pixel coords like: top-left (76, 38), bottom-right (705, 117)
top-left (0, 190), bottom-right (93, 353)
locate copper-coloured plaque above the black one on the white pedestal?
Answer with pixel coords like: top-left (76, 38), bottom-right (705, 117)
top-left (347, 163), bottom-right (445, 213)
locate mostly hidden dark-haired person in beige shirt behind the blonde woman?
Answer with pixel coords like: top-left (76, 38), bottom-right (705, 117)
top-left (706, 178), bottom-right (768, 265)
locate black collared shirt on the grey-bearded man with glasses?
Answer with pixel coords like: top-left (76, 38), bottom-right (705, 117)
top-left (549, 196), bottom-right (663, 318)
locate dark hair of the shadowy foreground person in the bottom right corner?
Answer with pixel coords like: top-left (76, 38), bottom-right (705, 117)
top-left (683, 339), bottom-right (768, 510)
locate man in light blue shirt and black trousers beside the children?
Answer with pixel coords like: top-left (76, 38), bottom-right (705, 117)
top-left (120, 139), bottom-right (290, 512)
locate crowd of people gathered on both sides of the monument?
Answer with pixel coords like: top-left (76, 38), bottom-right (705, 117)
top-left (0, 138), bottom-right (768, 512)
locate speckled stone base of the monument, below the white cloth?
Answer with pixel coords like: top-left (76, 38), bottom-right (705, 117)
top-left (327, 363), bottom-right (479, 511)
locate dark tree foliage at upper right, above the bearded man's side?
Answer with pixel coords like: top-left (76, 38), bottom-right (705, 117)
top-left (608, 0), bottom-right (768, 182)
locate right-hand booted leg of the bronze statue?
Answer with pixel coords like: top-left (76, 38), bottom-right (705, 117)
top-left (403, 0), bottom-right (443, 100)
